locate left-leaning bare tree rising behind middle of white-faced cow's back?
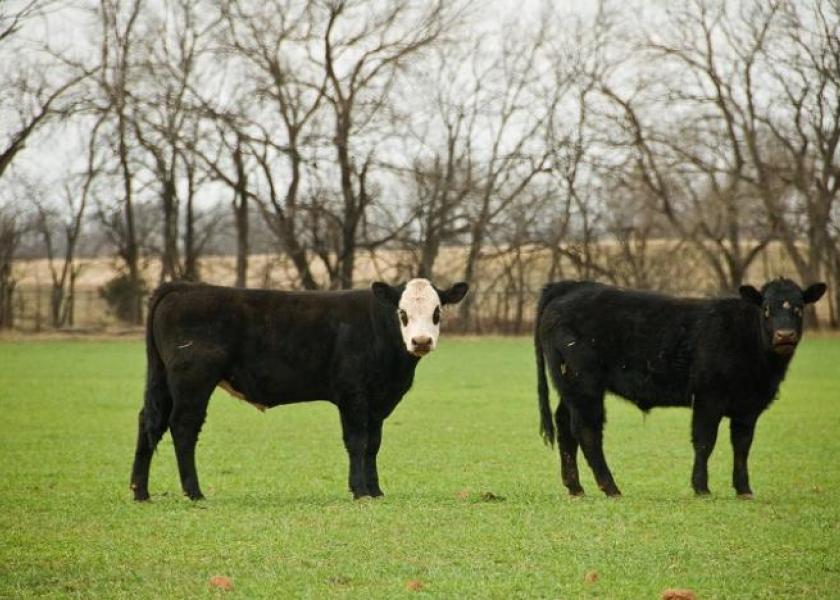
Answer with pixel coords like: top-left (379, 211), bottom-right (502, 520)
top-left (213, 0), bottom-right (326, 289)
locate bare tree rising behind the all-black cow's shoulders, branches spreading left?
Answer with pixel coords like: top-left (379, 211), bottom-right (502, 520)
top-left (597, 0), bottom-right (773, 290)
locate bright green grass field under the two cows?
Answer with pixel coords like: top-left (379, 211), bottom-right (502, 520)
top-left (0, 338), bottom-right (840, 599)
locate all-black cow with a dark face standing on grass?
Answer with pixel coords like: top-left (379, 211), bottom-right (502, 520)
top-left (534, 278), bottom-right (826, 498)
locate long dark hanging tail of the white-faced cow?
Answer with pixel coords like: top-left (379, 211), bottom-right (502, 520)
top-left (143, 284), bottom-right (175, 448)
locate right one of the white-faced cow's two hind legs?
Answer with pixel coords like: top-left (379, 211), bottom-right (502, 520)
top-left (169, 374), bottom-right (218, 500)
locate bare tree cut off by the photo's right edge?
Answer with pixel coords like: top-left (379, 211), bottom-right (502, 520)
top-left (760, 0), bottom-right (840, 324)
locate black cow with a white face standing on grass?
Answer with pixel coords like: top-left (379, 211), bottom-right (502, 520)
top-left (131, 279), bottom-right (468, 501)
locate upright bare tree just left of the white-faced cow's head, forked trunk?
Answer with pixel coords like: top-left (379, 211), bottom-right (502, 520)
top-left (319, 0), bottom-right (460, 288)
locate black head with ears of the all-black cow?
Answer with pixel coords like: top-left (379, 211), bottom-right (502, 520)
top-left (738, 277), bottom-right (825, 356)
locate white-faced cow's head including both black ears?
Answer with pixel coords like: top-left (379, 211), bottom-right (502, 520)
top-left (371, 279), bottom-right (469, 357)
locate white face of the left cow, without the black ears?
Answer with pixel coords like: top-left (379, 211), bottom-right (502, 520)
top-left (398, 279), bottom-right (440, 356)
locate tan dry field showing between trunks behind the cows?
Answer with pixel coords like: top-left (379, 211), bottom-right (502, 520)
top-left (12, 240), bottom-right (834, 333)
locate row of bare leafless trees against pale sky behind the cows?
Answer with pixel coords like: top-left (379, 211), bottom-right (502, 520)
top-left (0, 0), bottom-right (840, 327)
